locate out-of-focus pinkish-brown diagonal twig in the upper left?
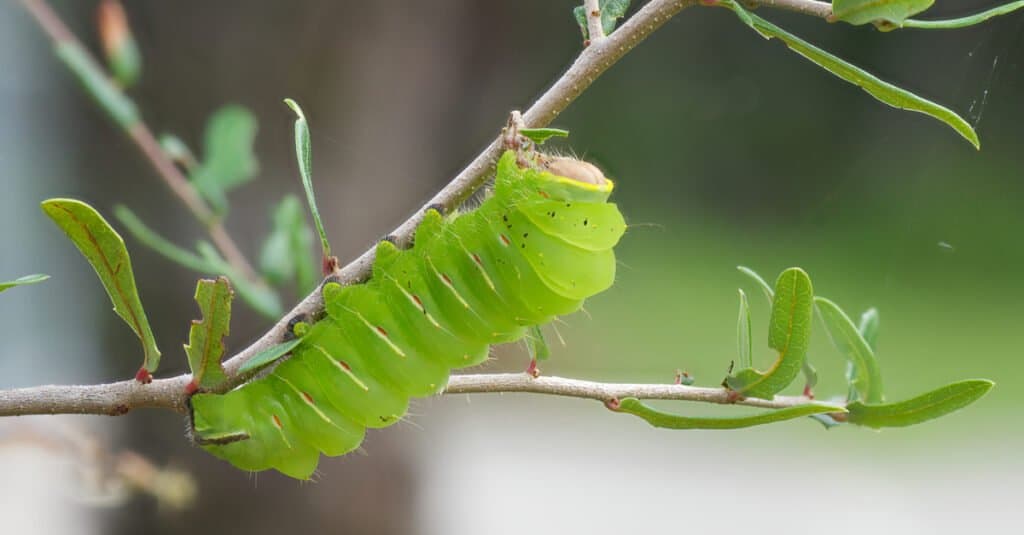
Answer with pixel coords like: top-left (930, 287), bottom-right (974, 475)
top-left (22, 0), bottom-right (266, 286)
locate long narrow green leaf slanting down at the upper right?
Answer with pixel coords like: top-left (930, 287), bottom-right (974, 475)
top-left (718, 0), bottom-right (981, 149)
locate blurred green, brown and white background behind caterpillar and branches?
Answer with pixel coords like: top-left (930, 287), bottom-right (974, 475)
top-left (0, 0), bottom-right (1024, 534)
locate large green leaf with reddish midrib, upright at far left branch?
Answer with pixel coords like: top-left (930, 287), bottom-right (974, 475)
top-left (42, 199), bottom-right (160, 373)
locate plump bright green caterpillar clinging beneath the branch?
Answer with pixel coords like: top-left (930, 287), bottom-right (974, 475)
top-left (191, 151), bottom-right (626, 479)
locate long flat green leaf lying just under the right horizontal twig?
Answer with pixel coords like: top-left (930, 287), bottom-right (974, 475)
top-left (613, 398), bottom-right (846, 429)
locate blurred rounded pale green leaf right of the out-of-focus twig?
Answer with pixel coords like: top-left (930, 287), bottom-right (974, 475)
top-left (189, 106), bottom-right (259, 213)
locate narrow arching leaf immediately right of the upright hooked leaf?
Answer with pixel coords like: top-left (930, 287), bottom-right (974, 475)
top-left (814, 296), bottom-right (884, 403)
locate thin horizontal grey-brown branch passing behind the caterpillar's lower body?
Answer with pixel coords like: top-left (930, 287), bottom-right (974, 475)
top-left (0, 373), bottom-right (810, 416)
